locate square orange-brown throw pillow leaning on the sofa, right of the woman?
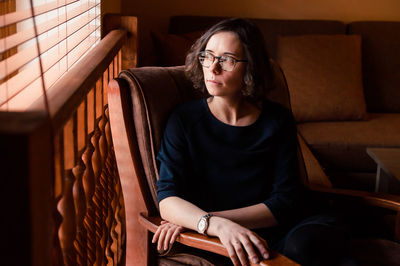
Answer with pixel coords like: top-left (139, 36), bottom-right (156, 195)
top-left (278, 35), bottom-right (366, 122)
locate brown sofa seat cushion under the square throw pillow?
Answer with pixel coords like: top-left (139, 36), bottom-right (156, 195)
top-left (298, 113), bottom-right (400, 172)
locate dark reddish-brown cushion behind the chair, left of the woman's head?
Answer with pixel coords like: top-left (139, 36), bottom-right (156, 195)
top-left (151, 31), bottom-right (202, 66)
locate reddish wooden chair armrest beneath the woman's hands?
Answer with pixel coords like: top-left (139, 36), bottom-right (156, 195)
top-left (139, 213), bottom-right (299, 266)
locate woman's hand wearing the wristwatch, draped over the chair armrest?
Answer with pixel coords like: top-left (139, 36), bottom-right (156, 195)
top-left (208, 216), bottom-right (269, 266)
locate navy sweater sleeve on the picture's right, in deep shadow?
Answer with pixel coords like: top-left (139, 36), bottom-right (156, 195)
top-left (264, 110), bottom-right (300, 224)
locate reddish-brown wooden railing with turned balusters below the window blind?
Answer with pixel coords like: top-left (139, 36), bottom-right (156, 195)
top-left (0, 17), bottom-right (137, 266)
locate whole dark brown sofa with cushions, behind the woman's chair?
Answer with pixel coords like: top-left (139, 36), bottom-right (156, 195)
top-left (146, 16), bottom-right (400, 191)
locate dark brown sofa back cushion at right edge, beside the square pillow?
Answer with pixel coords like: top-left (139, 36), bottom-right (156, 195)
top-left (349, 21), bottom-right (400, 113)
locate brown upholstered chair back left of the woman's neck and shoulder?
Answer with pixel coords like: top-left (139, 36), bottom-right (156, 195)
top-left (119, 67), bottom-right (200, 205)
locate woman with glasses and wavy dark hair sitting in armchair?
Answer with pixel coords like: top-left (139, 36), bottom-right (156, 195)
top-left (153, 19), bottom-right (354, 265)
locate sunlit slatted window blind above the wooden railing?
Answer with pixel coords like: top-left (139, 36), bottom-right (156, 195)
top-left (0, 0), bottom-right (100, 111)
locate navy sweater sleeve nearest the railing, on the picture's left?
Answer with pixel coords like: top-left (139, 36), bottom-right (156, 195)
top-left (157, 113), bottom-right (187, 202)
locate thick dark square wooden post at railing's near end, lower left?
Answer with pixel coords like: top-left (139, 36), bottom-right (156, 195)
top-left (0, 112), bottom-right (54, 266)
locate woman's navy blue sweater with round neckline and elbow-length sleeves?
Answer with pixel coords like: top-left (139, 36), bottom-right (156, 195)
top-left (157, 99), bottom-right (299, 224)
